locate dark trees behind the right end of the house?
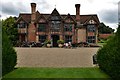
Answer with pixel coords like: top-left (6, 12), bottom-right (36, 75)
top-left (98, 23), bottom-right (114, 34)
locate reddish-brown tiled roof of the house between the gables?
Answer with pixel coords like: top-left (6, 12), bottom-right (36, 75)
top-left (18, 11), bottom-right (99, 24)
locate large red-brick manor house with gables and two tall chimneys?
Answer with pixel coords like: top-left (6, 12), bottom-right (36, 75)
top-left (16, 3), bottom-right (100, 46)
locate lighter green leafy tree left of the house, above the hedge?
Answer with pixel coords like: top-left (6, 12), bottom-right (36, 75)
top-left (2, 17), bottom-right (18, 45)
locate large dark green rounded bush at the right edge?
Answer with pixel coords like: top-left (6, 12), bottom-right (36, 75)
top-left (97, 26), bottom-right (120, 80)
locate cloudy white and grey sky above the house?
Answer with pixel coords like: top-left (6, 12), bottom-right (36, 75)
top-left (0, 0), bottom-right (120, 29)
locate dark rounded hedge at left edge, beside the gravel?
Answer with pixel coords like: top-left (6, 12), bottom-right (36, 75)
top-left (2, 29), bottom-right (17, 75)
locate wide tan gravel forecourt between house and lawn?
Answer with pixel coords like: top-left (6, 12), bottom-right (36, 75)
top-left (15, 48), bottom-right (98, 67)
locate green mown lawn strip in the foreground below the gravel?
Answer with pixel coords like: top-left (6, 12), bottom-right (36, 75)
top-left (3, 68), bottom-right (109, 78)
